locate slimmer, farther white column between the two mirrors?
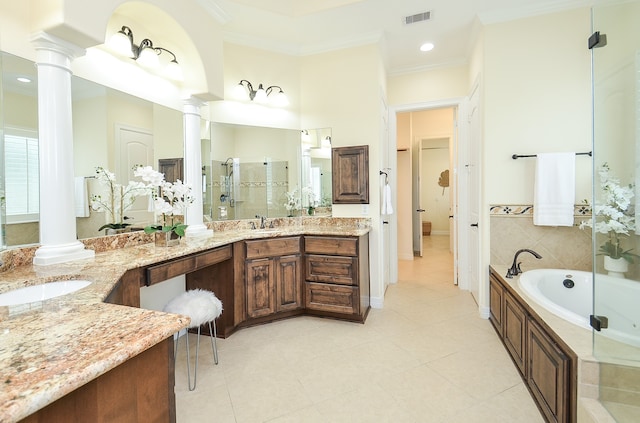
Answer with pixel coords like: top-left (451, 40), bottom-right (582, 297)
top-left (183, 97), bottom-right (213, 238)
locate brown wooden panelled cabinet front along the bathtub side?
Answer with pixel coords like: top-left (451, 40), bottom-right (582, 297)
top-left (489, 269), bottom-right (578, 423)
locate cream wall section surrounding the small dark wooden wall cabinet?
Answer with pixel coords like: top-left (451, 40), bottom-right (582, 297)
top-left (300, 45), bottom-right (386, 306)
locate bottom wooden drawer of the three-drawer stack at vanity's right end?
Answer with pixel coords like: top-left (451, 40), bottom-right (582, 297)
top-left (305, 282), bottom-right (360, 314)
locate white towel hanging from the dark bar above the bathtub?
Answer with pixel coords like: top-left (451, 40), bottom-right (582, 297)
top-left (533, 153), bottom-right (576, 226)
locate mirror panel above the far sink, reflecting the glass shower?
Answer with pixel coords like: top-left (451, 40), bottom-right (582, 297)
top-left (202, 122), bottom-right (300, 220)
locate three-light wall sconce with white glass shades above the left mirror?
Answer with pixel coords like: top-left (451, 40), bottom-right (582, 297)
top-left (109, 26), bottom-right (183, 81)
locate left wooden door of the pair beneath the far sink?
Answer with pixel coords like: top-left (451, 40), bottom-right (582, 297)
top-left (246, 259), bottom-right (276, 317)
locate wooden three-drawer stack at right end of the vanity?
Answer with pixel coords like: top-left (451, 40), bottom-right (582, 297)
top-left (304, 234), bottom-right (370, 322)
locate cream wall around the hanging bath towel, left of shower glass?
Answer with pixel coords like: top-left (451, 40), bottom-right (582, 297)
top-left (483, 8), bottom-right (592, 208)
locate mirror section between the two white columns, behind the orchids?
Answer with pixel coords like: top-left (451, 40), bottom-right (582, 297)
top-left (72, 76), bottom-right (184, 238)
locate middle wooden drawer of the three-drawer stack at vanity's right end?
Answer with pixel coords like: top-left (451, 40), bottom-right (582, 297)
top-left (305, 254), bottom-right (358, 285)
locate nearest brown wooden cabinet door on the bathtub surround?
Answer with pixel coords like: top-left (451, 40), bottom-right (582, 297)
top-left (527, 320), bottom-right (571, 422)
